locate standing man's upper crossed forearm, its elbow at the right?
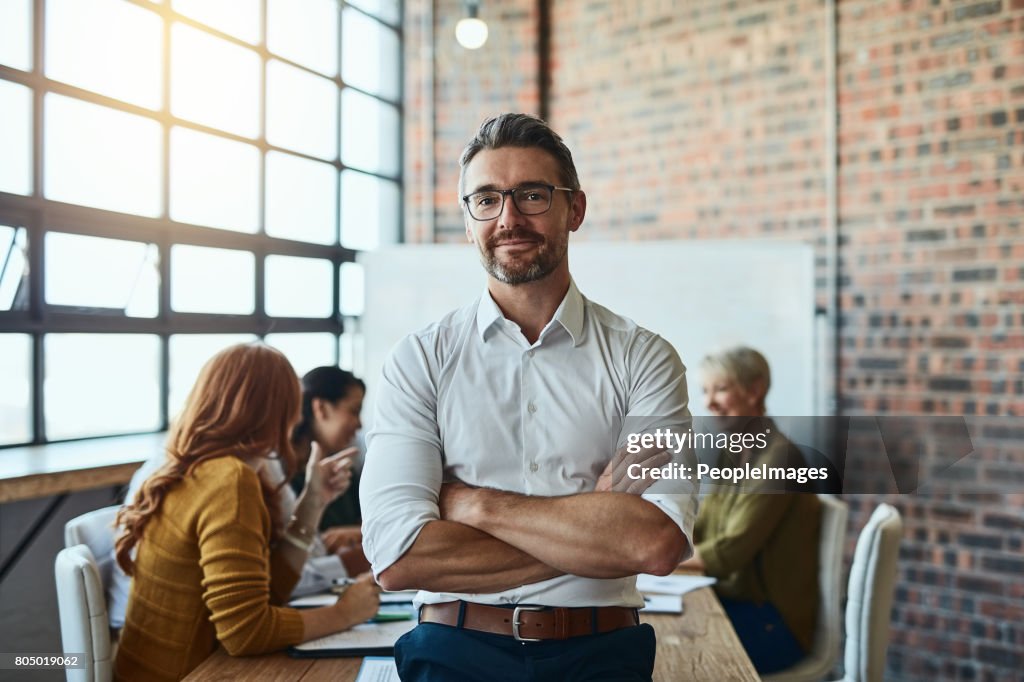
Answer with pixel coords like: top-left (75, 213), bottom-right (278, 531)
top-left (454, 488), bottom-right (687, 578)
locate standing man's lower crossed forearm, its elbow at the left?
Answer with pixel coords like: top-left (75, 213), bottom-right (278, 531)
top-left (378, 520), bottom-right (562, 592)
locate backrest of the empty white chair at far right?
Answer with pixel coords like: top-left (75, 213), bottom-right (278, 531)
top-left (845, 504), bottom-right (903, 682)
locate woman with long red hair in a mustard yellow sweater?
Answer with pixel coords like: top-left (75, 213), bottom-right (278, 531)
top-left (114, 343), bottom-right (379, 680)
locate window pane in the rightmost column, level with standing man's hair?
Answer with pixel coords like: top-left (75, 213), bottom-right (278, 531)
top-left (341, 89), bottom-right (399, 175)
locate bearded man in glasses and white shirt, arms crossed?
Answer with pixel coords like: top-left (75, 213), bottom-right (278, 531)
top-left (360, 114), bottom-right (696, 682)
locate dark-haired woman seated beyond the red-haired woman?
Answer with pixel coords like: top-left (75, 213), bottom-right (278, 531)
top-left (292, 366), bottom-right (370, 574)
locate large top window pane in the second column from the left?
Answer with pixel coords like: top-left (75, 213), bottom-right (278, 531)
top-left (45, 0), bottom-right (164, 110)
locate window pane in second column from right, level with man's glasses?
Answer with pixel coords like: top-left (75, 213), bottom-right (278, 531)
top-left (266, 152), bottom-right (338, 244)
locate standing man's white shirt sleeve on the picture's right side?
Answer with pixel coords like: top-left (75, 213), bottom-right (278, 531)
top-left (620, 333), bottom-right (697, 558)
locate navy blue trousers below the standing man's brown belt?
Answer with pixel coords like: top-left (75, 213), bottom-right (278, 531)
top-left (394, 623), bottom-right (655, 682)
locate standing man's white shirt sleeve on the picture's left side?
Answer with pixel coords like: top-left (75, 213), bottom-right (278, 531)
top-left (359, 336), bottom-right (443, 577)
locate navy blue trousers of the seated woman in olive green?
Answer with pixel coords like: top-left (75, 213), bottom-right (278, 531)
top-left (719, 597), bottom-right (806, 675)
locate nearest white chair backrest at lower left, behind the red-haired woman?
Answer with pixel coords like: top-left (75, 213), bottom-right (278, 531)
top-left (53, 545), bottom-right (113, 682)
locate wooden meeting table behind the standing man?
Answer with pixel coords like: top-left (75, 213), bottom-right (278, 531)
top-left (185, 588), bottom-right (761, 682)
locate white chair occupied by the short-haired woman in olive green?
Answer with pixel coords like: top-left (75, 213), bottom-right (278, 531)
top-left (762, 495), bottom-right (850, 682)
